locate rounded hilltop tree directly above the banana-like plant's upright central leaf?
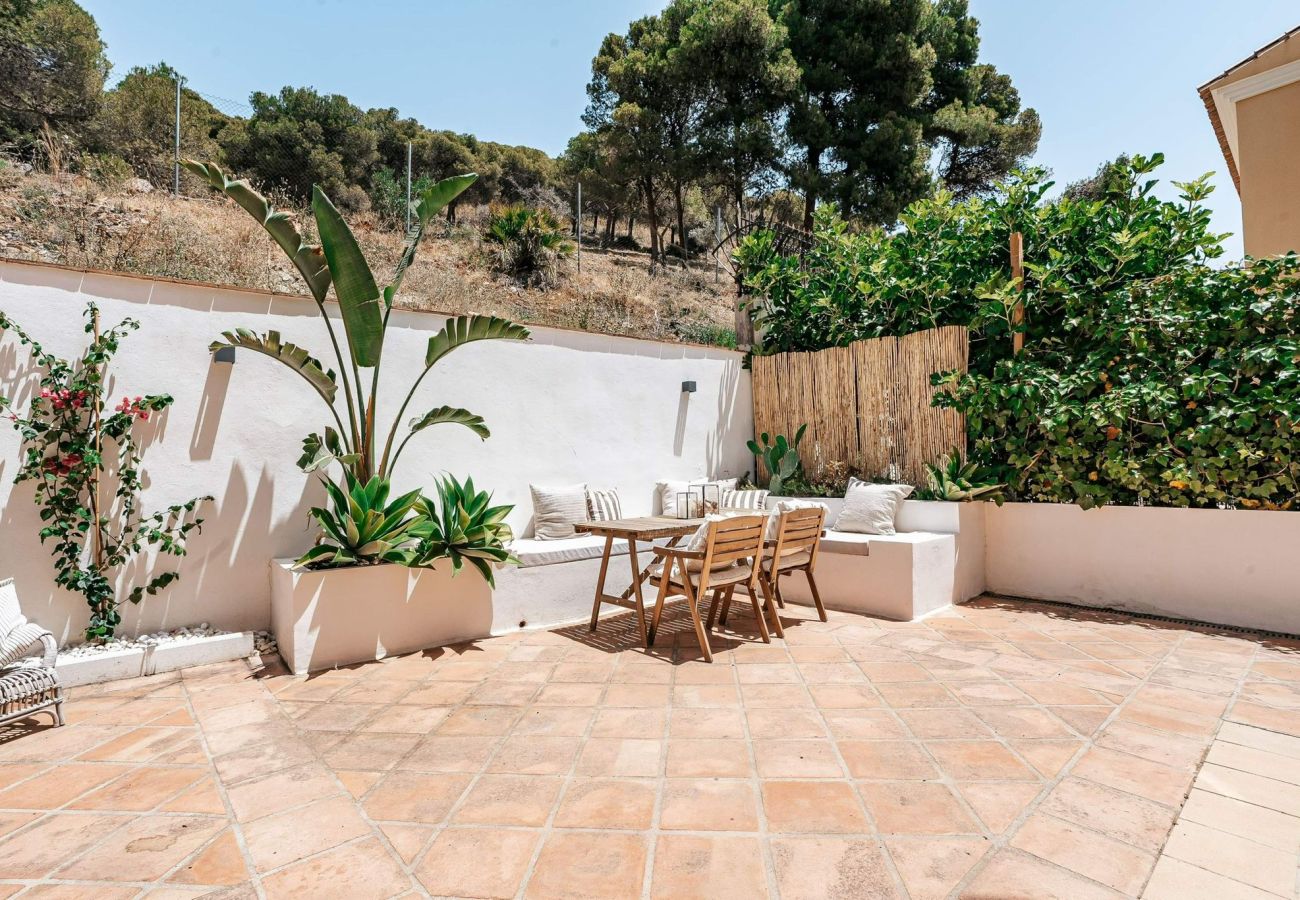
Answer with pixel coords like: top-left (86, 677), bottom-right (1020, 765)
top-left (225, 87), bottom-right (377, 209)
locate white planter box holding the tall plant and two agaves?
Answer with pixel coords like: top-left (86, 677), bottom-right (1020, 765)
top-left (270, 559), bottom-right (493, 675)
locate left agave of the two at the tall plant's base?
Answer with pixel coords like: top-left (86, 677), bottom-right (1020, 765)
top-left (298, 470), bottom-right (420, 568)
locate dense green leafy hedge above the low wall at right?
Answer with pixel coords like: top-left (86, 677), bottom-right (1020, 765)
top-left (740, 155), bottom-right (1300, 509)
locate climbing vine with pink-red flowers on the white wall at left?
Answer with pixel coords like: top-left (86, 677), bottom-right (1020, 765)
top-left (0, 303), bottom-right (212, 641)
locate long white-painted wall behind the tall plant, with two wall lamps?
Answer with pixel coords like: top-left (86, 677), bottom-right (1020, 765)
top-left (0, 261), bottom-right (753, 640)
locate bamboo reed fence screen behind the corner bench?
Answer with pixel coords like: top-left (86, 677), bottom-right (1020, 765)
top-left (753, 325), bottom-right (969, 484)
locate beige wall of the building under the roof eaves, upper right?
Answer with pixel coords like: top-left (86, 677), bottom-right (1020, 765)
top-left (1236, 82), bottom-right (1300, 256)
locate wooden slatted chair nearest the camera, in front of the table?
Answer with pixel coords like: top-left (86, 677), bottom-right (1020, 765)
top-left (647, 515), bottom-right (776, 662)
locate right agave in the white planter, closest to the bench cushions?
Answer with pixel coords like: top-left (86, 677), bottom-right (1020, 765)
top-left (411, 475), bottom-right (519, 587)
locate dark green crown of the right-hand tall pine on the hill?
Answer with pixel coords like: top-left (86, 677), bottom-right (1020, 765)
top-left (772, 0), bottom-right (1041, 229)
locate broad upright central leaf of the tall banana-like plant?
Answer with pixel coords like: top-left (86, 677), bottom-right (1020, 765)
top-left (312, 186), bottom-right (384, 368)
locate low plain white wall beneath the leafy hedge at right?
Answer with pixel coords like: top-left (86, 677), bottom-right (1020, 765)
top-left (984, 503), bottom-right (1300, 633)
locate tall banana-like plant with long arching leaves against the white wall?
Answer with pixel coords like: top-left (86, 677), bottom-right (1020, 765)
top-left (181, 160), bottom-right (528, 484)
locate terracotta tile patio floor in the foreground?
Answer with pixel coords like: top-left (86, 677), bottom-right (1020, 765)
top-left (0, 598), bottom-right (1300, 900)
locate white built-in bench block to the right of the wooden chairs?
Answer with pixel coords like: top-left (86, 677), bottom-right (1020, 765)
top-left (781, 498), bottom-right (984, 622)
